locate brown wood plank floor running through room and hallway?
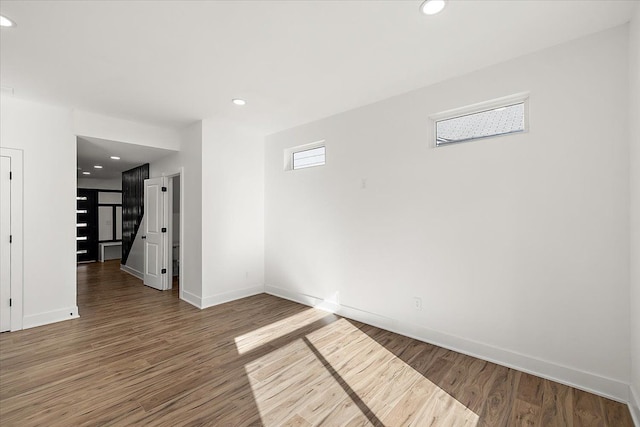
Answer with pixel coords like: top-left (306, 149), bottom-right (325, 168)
top-left (0, 261), bottom-right (633, 427)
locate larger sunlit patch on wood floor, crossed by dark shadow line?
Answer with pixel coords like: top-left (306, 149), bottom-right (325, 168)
top-left (245, 319), bottom-right (478, 427)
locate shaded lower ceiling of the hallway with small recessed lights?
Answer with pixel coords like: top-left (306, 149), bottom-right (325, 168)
top-left (77, 137), bottom-right (175, 179)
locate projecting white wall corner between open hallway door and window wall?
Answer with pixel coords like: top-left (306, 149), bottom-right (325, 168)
top-left (147, 120), bottom-right (264, 308)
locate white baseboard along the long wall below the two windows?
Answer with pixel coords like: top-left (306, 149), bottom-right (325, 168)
top-left (265, 285), bottom-right (629, 403)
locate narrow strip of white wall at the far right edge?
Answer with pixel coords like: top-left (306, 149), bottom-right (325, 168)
top-left (629, 5), bottom-right (640, 425)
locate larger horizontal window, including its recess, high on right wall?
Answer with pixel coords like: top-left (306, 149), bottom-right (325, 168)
top-left (432, 94), bottom-right (528, 146)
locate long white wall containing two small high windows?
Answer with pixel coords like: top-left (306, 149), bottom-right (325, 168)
top-left (265, 27), bottom-right (630, 401)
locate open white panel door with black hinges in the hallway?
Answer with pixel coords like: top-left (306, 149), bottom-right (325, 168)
top-left (142, 177), bottom-right (169, 290)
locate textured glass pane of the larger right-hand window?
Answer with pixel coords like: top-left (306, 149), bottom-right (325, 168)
top-left (436, 102), bottom-right (525, 146)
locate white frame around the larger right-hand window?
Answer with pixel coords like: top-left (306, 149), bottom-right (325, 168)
top-left (429, 92), bottom-right (530, 148)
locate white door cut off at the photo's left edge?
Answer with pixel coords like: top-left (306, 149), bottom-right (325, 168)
top-left (0, 156), bottom-right (11, 332)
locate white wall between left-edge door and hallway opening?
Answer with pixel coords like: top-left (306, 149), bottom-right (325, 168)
top-left (0, 96), bottom-right (78, 328)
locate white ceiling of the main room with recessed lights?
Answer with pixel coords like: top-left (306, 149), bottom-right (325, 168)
top-left (0, 0), bottom-right (637, 138)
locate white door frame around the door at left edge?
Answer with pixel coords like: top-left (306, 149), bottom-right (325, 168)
top-left (0, 147), bottom-right (24, 332)
